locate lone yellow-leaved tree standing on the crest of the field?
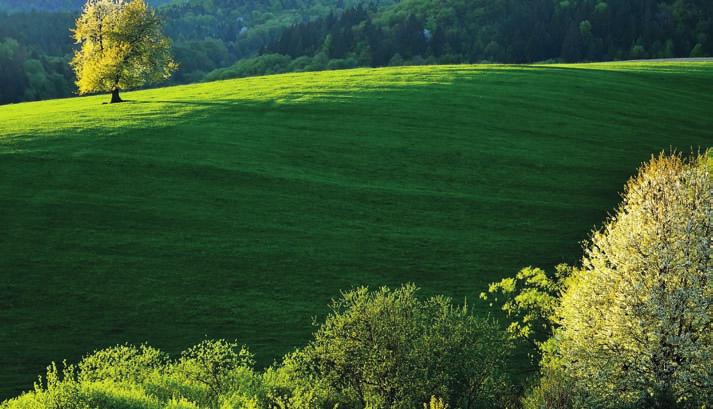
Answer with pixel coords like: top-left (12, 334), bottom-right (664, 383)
top-left (71, 0), bottom-right (177, 103)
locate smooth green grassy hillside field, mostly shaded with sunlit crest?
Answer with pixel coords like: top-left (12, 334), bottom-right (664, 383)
top-left (0, 63), bottom-right (713, 398)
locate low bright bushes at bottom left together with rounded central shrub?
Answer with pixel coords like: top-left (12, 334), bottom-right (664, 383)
top-left (0, 285), bottom-right (511, 409)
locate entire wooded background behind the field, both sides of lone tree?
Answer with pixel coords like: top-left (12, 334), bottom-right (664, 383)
top-left (0, 0), bottom-right (713, 103)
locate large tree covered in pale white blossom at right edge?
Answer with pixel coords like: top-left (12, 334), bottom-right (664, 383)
top-left (555, 154), bottom-right (713, 407)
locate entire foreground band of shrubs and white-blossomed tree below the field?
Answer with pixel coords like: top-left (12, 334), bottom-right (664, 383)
top-left (0, 151), bottom-right (713, 409)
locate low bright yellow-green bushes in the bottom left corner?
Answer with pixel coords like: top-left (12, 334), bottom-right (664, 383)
top-left (0, 340), bottom-right (264, 409)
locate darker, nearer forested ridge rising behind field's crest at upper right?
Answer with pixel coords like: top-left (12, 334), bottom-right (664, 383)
top-left (209, 0), bottom-right (713, 78)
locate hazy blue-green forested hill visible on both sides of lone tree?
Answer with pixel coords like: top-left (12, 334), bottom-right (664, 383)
top-left (0, 0), bottom-right (396, 104)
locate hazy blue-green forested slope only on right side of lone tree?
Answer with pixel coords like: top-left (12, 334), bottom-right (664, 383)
top-left (160, 0), bottom-right (398, 83)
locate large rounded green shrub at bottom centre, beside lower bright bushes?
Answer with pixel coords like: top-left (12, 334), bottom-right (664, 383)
top-left (296, 285), bottom-right (510, 408)
